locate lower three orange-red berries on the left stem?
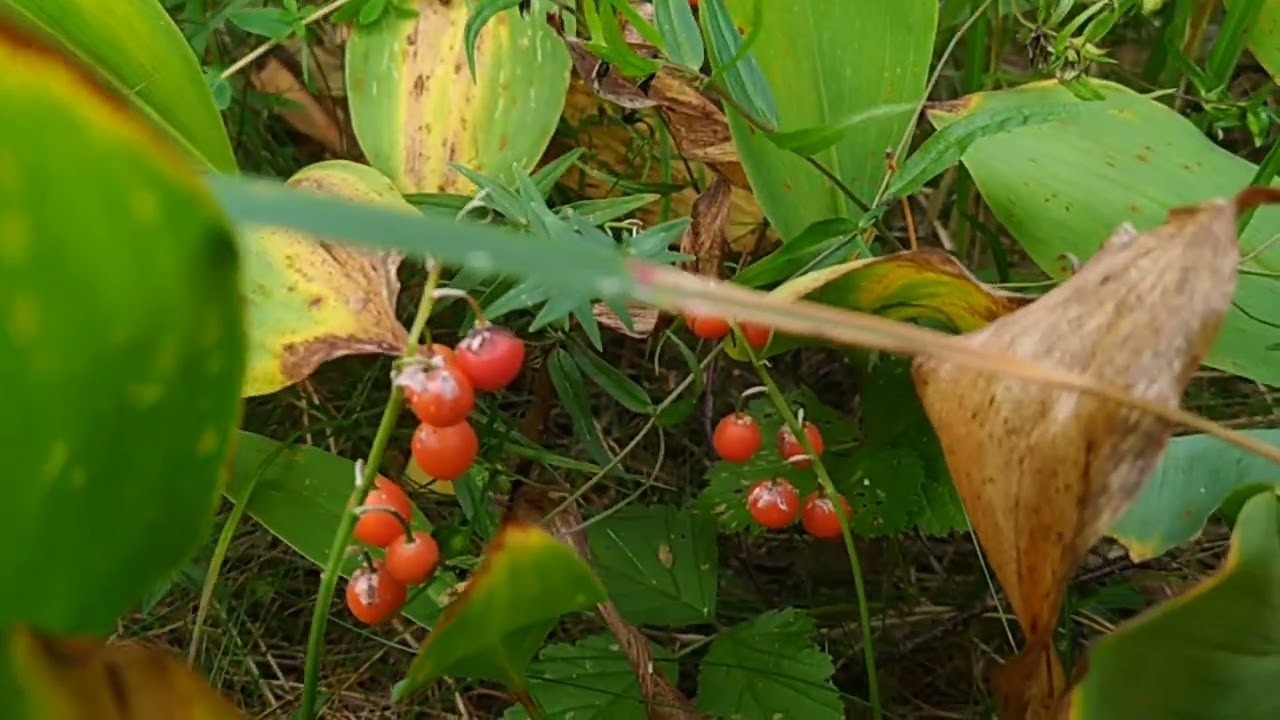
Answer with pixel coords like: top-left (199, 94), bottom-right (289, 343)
top-left (347, 475), bottom-right (440, 625)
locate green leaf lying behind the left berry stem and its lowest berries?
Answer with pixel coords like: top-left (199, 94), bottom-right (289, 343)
top-left (225, 432), bottom-right (456, 628)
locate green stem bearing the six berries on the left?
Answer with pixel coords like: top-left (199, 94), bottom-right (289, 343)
top-left (298, 263), bottom-right (440, 720)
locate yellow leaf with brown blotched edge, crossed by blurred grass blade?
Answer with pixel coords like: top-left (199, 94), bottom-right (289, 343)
top-left (241, 160), bottom-right (417, 397)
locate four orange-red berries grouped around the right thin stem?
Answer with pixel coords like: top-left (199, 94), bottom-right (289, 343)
top-left (712, 407), bottom-right (849, 538)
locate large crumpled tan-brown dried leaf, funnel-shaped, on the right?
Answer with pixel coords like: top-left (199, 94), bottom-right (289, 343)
top-left (913, 201), bottom-right (1239, 719)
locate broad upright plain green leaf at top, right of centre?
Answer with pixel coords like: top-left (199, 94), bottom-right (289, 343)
top-left (721, 0), bottom-right (938, 242)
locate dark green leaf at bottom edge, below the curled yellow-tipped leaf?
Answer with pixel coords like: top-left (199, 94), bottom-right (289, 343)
top-left (503, 635), bottom-right (678, 720)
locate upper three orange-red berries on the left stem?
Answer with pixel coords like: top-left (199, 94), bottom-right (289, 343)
top-left (396, 322), bottom-right (525, 482)
